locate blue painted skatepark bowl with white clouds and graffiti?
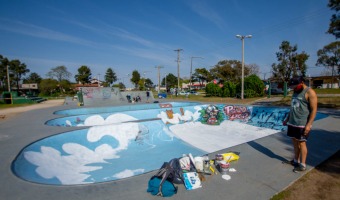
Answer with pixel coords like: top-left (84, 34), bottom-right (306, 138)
top-left (12, 102), bottom-right (327, 185)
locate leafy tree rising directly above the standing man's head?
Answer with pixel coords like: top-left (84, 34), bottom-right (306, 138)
top-left (272, 41), bottom-right (309, 81)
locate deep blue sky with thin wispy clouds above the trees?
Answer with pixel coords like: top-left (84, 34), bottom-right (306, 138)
top-left (0, 0), bottom-right (335, 84)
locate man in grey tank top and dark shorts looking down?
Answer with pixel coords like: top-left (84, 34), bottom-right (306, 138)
top-left (283, 76), bottom-right (317, 172)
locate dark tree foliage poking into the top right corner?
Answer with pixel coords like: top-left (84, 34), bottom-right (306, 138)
top-left (327, 0), bottom-right (340, 39)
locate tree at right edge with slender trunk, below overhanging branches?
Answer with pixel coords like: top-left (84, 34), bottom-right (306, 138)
top-left (316, 41), bottom-right (340, 88)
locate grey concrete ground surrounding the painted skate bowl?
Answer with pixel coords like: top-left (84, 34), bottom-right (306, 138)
top-left (0, 101), bottom-right (340, 200)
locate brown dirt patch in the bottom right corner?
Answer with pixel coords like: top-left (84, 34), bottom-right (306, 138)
top-left (272, 151), bottom-right (340, 200)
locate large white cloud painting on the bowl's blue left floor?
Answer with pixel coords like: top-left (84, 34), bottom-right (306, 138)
top-left (24, 123), bottom-right (143, 185)
